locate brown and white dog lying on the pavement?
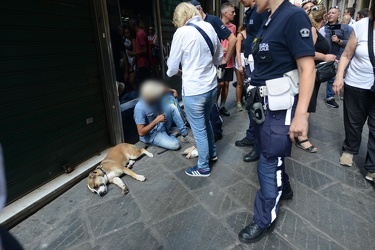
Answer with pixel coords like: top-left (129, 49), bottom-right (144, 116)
top-left (87, 143), bottom-right (153, 196)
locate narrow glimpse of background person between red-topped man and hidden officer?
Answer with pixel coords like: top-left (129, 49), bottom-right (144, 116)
top-left (234, 24), bottom-right (246, 111)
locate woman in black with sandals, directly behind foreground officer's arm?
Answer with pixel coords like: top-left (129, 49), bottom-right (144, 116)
top-left (296, 5), bottom-right (336, 153)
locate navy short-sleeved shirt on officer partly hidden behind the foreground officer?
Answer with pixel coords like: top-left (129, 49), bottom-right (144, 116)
top-left (244, 5), bottom-right (268, 58)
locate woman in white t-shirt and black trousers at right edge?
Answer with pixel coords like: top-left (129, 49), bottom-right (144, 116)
top-left (333, 0), bottom-right (375, 181)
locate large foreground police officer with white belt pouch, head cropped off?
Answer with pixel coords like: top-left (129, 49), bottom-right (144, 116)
top-left (238, 0), bottom-right (315, 243)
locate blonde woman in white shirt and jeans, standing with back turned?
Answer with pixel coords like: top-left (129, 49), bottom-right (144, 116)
top-left (167, 2), bottom-right (223, 177)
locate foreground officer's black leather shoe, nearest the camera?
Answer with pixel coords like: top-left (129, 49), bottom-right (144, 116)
top-left (238, 221), bottom-right (275, 244)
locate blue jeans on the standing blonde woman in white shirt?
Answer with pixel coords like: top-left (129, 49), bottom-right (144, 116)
top-left (182, 88), bottom-right (217, 170)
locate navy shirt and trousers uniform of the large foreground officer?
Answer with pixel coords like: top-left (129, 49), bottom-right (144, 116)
top-left (251, 0), bottom-right (315, 228)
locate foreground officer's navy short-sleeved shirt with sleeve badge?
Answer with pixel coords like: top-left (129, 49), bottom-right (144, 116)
top-left (251, 0), bottom-right (315, 86)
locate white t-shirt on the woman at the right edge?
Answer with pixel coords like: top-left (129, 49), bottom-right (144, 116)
top-left (345, 18), bottom-right (375, 89)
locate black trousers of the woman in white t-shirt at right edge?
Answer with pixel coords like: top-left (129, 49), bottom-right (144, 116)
top-left (342, 84), bottom-right (375, 172)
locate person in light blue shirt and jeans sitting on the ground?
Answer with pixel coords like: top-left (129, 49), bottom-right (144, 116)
top-left (134, 81), bottom-right (194, 150)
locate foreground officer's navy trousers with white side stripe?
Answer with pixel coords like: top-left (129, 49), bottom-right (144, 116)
top-left (253, 97), bottom-right (298, 228)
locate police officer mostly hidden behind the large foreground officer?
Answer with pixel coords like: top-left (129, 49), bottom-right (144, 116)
top-left (235, 0), bottom-right (267, 162)
